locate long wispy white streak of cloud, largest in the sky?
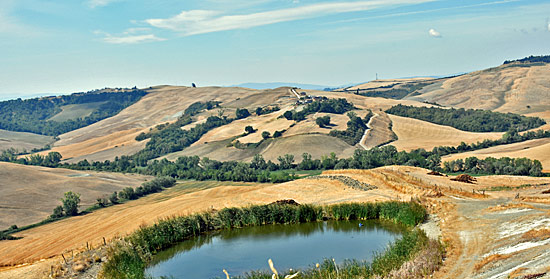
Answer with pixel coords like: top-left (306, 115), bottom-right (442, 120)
top-left (145, 0), bottom-right (435, 36)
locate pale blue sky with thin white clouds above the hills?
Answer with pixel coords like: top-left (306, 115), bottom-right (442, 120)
top-left (0, 0), bottom-right (550, 99)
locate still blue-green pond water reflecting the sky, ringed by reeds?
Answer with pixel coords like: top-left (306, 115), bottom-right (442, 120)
top-left (146, 220), bottom-right (401, 279)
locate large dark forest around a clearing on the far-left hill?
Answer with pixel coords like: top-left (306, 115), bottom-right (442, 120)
top-left (0, 90), bottom-right (147, 136)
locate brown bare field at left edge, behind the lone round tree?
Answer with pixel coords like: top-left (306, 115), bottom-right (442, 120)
top-left (0, 162), bottom-right (148, 230)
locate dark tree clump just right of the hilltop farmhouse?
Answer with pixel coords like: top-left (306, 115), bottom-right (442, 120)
top-left (283, 98), bottom-right (354, 121)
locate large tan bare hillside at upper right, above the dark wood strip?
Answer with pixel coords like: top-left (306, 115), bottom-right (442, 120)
top-left (410, 64), bottom-right (550, 114)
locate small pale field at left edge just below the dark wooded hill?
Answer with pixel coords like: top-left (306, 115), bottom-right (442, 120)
top-left (0, 129), bottom-right (54, 151)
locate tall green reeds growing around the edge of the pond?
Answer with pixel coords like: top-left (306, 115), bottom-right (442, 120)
top-left (102, 201), bottom-right (436, 278)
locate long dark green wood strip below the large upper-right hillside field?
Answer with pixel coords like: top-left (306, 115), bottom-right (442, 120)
top-left (386, 104), bottom-right (546, 132)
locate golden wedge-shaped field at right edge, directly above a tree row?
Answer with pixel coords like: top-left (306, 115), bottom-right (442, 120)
top-left (442, 139), bottom-right (550, 171)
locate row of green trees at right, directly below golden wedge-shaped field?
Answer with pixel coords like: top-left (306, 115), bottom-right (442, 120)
top-left (443, 157), bottom-right (543, 176)
